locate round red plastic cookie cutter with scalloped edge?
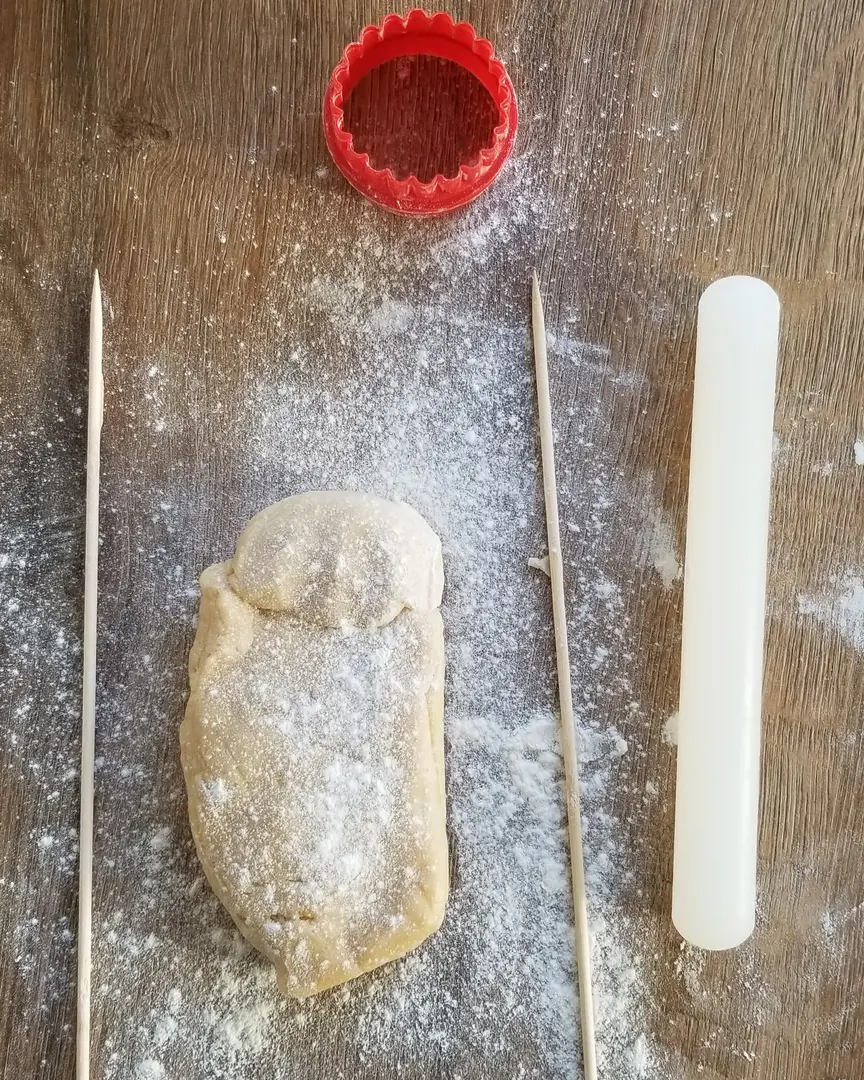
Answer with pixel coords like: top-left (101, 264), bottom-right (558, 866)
top-left (323, 9), bottom-right (517, 215)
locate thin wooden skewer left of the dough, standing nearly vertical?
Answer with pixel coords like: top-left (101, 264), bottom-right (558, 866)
top-left (76, 270), bottom-right (103, 1080)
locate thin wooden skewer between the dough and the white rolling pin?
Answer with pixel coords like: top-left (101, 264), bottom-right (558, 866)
top-left (531, 271), bottom-right (597, 1080)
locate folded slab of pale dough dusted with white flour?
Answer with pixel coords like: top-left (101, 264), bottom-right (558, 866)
top-left (180, 491), bottom-right (448, 998)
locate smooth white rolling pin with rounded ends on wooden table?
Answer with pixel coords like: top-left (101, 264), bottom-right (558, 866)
top-left (672, 276), bottom-right (780, 949)
